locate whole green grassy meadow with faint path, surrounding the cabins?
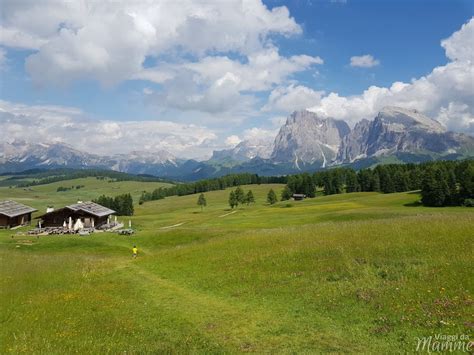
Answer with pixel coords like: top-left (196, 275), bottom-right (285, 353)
top-left (0, 179), bottom-right (474, 354)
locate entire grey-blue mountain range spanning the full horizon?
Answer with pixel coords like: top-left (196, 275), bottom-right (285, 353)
top-left (0, 107), bottom-right (474, 180)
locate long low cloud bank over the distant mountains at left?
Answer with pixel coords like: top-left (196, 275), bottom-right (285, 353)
top-left (0, 101), bottom-right (217, 158)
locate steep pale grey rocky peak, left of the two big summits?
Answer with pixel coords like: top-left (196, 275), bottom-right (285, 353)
top-left (271, 111), bottom-right (350, 168)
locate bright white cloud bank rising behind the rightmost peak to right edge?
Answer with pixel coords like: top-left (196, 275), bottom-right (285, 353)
top-left (310, 19), bottom-right (474, 134)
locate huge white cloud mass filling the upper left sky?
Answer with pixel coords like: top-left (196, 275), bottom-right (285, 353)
top-left (0, 0), bottom-right (323, 116)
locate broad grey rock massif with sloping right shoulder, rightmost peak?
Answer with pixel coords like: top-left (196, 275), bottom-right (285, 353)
top-left (337, 107), bottom-right (473, 162)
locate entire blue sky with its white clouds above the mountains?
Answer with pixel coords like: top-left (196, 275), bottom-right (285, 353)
top-left (0, 0), bottom-right (474, 157)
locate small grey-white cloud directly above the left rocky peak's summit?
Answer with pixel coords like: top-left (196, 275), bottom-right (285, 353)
top-left (262, 84), bottom-right (324, 113)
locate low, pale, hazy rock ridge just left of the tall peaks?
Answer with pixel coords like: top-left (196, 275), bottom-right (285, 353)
top-left (211, 138), bottom-right (273, 162)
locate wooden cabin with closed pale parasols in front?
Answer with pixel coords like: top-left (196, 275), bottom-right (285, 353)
top-left (39, 202), bottom-right (115, 228)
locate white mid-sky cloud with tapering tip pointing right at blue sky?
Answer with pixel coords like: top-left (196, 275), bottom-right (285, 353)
top-left (148, 46), bottom-right (323, 113)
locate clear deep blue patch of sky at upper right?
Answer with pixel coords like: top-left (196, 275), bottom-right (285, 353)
top-left (274, 0), bottom-right (474, 95)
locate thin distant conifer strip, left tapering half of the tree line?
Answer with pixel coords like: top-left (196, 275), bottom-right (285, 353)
top-left (139, 173), bottom-right (287, 204)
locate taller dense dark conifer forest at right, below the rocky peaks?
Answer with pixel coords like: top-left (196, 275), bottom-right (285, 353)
top-left (281, 160), bottom-right (474, 206)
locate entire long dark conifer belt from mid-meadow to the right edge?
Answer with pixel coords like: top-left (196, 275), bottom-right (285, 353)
top-left (139, 159), bottom-right (474, 207)
